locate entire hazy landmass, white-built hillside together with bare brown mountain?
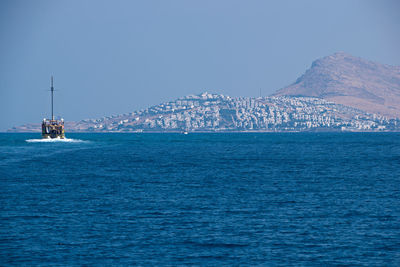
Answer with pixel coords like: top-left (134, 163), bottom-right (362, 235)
top-left (11, 53), bottom-right (400, 132)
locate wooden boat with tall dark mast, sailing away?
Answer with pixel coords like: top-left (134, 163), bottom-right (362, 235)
top-left (42, 76), bottom-right (65, 139)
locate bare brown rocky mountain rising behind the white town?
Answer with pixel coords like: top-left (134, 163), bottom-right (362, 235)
top-left (274, 52), bottom-right (400, 118)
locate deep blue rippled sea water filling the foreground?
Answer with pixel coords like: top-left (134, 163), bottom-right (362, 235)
top-left (0, 133), bottom-right (400, 266)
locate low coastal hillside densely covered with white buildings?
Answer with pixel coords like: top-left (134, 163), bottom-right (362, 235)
top-left (11, 93), bottom-right (400, 133)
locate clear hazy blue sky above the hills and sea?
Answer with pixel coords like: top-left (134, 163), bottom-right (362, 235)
top-left (0, 0), bottom-right (400, 131)
